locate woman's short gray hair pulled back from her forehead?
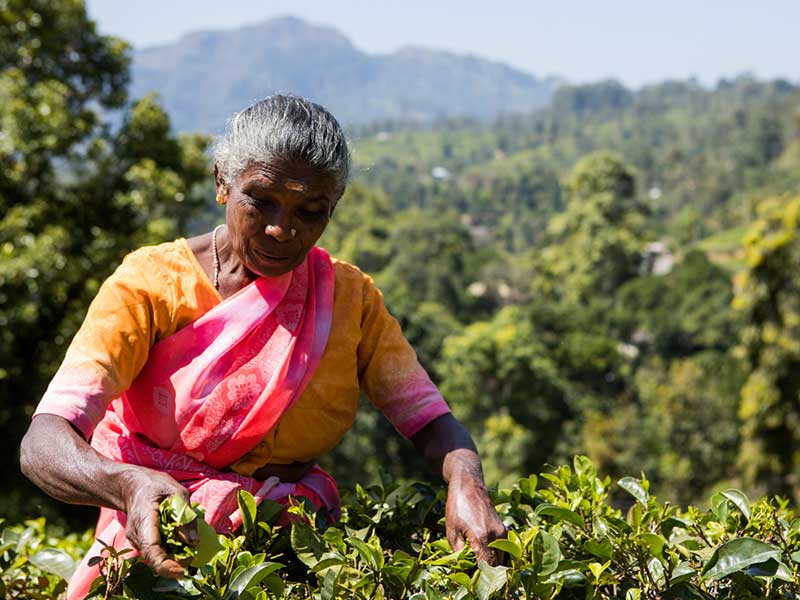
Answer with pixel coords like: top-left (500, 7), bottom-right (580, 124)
top-left (214, 94), bottom-right (350, 196)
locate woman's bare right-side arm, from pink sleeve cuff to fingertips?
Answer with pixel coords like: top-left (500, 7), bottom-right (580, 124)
top-left (411, 414), bottom-right (506, 564)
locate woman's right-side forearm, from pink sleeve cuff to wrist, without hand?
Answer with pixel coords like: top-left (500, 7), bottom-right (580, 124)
top-left (411, 413), bottom-right (483, 483)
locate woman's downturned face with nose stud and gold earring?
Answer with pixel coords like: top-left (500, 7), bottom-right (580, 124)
top-left (217, 160), bottom-right (338, 277)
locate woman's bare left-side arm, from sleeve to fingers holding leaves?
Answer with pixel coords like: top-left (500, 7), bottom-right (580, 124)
top-left (20, 414), bottom-right (198, 577)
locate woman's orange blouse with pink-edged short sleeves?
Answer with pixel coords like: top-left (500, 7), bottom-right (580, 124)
top-left (36, 239), bottom-right (449, 475)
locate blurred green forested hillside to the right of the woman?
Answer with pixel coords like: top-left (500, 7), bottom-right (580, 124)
top-left (318, 76), bottom-right (800, 502)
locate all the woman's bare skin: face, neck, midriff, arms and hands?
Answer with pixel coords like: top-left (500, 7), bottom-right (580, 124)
top-left (20, 162), bottom-right (505, 578)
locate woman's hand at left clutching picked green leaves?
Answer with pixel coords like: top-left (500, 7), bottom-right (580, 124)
top-left (119, 466), bottom-right (200, 579)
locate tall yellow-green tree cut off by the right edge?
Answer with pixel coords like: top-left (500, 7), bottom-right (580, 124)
top-left (734, 197), bottom-right (800, 494)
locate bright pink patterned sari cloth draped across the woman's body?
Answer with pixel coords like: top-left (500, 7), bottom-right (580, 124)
top-left (67, 248), bottom-right (341, 600)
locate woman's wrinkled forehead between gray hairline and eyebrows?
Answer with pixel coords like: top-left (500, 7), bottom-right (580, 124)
top-left (235, 159), bottom-right (336, 197)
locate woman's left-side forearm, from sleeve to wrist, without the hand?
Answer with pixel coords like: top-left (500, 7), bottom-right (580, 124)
top-left (20, 414), bottom-right (138, 510)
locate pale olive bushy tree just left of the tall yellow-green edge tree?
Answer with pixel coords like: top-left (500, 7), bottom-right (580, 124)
top-left (581, 351), bottom-right (744, 504)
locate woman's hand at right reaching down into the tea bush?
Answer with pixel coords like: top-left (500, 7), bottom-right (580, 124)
top-left (445, 474), bottom-right (506, 565)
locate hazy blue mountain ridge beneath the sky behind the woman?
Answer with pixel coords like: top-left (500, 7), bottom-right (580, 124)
top-left (131, 17), bottom-right (551, 132)
